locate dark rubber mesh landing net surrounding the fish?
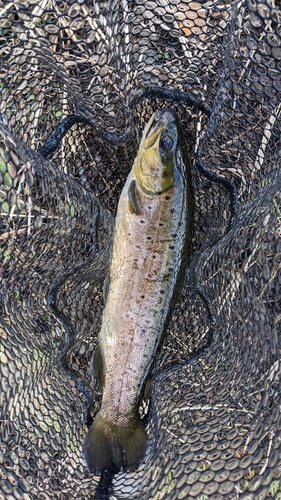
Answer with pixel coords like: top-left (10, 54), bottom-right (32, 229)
top-left (0, 0), bottom-right (281, 500)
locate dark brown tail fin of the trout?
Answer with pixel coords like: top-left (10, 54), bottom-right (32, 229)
top-left (82, 410), bottom-right (147, 474)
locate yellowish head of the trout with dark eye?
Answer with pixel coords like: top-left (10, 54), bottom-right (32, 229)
top-left (133, 109), bottom-right (179, 195)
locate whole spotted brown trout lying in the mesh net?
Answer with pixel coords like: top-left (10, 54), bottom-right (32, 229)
top-left (83, 110), bottom-right (193, 474)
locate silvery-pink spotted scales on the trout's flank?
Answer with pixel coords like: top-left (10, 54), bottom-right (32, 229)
top-left (101, 185), bottom-right (183, 418)
